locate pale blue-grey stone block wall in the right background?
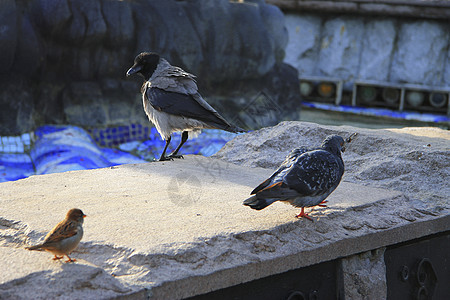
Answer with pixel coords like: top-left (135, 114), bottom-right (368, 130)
top-left (285, 13), bottom-right (450, 89)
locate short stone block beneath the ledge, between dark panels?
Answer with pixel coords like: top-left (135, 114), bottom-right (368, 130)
top-left (342, 248), bottom-right (387, 300)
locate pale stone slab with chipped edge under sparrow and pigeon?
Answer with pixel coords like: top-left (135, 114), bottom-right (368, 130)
top-left (0, 156), bottom-right (450, 299)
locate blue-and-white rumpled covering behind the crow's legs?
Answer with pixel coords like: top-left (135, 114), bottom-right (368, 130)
top-left (0, 124), bottom-right (235, 182)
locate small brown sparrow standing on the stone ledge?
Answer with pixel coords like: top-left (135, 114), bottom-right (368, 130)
top-left (25, 208), bottom-right (86, 262)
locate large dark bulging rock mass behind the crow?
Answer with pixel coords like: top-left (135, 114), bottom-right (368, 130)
top-left (0, 0), bottom-right (298, 135)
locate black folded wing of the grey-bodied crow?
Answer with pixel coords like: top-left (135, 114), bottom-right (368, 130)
top-left (145, 86), bottom-right (241, 132)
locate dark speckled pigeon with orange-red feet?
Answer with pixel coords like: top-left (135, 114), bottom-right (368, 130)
top-left (243, 135), bottom-right (351, 221)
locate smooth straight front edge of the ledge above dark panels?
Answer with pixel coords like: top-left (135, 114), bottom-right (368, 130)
top-left (149, 215), bottom-right (450, 299)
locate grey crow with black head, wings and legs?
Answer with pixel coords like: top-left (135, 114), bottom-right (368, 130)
top-left (127, 52), bottom-right (244, 161)
